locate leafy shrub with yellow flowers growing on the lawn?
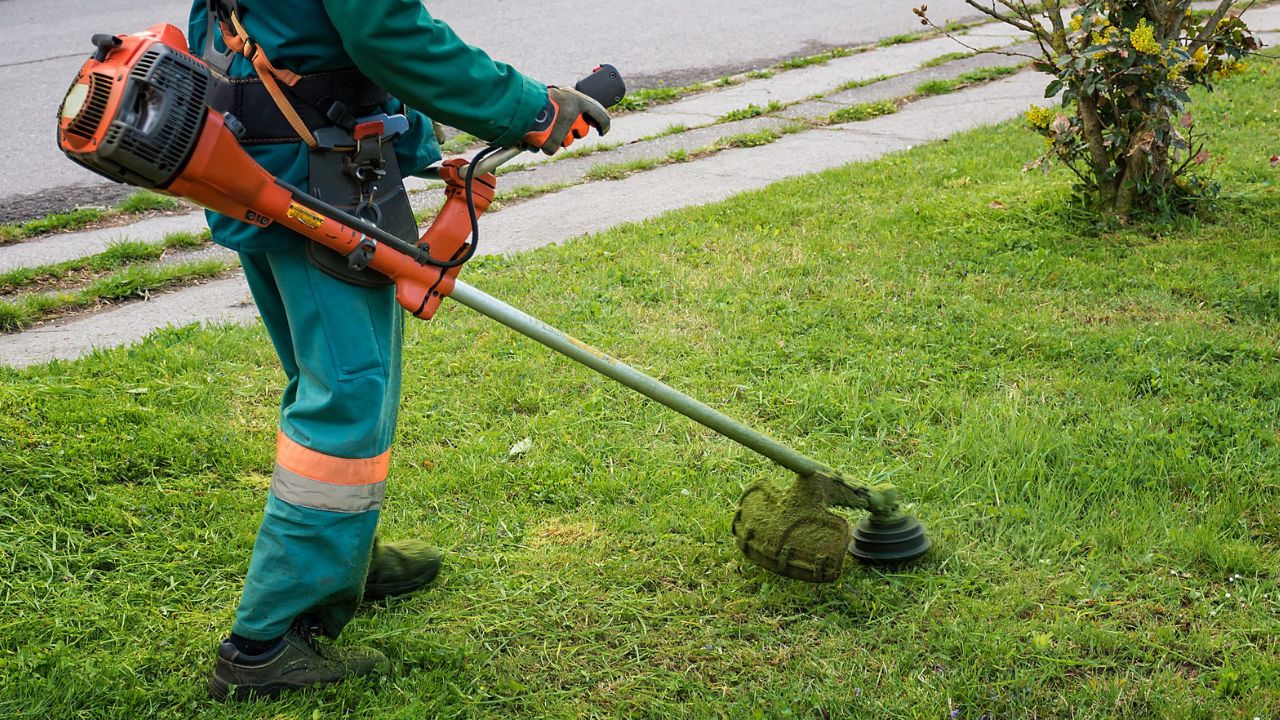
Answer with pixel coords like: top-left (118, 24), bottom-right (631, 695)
top-left (914, 0), bottom-right (1258, 222)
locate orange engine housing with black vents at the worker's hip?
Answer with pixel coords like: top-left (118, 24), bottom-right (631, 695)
top-left (58, 24), bottom-right (497, 319)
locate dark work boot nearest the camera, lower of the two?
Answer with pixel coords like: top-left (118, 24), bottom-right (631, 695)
top-left (209, 623), bottom-right (387, 700)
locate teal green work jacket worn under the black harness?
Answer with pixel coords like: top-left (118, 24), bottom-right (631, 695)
top-left (187, 0), bottom-right (547, 252)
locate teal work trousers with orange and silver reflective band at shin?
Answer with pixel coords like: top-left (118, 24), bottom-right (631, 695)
top-left (233, 238), bottom-right (403, 639)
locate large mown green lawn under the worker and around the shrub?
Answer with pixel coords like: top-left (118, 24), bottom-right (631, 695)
top-left (0, 65), bottom-right (1280, 720)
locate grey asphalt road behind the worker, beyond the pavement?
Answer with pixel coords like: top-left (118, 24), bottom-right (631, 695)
top-left (0, 0), bottom-right (973, 208)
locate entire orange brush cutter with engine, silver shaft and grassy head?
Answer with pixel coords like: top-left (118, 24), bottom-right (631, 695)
top-left (59, 24), bottom-right (929, 583)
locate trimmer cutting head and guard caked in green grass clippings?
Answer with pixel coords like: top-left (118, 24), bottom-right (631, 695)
top-left (733, 473), bottom-right (931, 583)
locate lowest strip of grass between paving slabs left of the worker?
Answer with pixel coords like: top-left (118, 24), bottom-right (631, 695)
top-left (0, 259), bottom-right (236, 332)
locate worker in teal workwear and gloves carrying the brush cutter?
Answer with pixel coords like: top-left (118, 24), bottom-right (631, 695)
top-left (188, 0), bottom-right (609, 700)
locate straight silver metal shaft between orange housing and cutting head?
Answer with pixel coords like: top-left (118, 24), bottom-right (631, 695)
top-left (449, 281), bottom-right (829, 477)
